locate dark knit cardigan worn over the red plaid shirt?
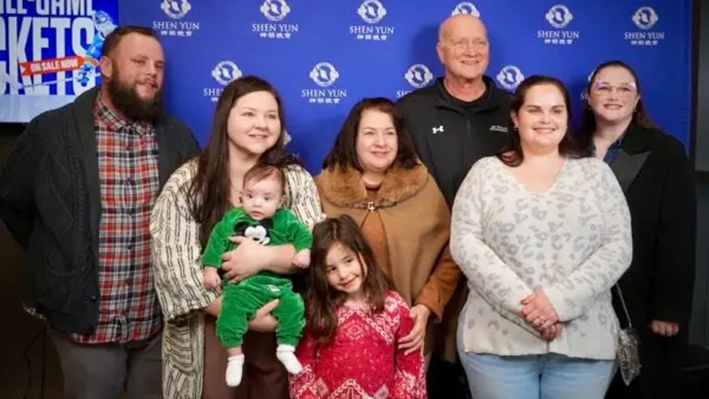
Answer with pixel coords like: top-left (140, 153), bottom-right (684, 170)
top-left (0, 88), bottom-right (199, 334)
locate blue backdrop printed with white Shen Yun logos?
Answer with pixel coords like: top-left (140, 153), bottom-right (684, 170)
top-left (119, 0), bottom-right (692, 172)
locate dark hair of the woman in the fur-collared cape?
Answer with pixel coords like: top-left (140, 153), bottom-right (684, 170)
top-left (322, 97), bottom-right (419, 172)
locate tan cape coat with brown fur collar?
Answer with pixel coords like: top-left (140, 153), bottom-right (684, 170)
top-left (315, 165), bottom-right (460, 360)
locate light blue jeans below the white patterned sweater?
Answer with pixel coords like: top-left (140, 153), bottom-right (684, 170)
top-left (458, 328), bottom-right (615, 399)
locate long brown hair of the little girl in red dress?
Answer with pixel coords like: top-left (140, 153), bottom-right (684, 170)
top-left (305, 215), bottom-right (392, 342)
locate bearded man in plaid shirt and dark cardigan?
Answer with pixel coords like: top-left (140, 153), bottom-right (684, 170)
top-left (0, 26), bottom-right (199, 399)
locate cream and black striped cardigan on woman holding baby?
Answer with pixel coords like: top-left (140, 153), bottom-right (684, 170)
top-left (150, 160), bottom-right (324, 399)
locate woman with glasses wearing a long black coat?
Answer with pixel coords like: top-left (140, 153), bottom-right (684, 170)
top-left (577, 61), bottom-right (697, 399)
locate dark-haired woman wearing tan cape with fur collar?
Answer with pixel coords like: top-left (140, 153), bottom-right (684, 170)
top-left (315, 98), bottom-right (460, 366)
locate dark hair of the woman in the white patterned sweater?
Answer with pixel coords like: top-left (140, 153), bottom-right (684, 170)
top-left (497, 75), bottom-right (580, 167)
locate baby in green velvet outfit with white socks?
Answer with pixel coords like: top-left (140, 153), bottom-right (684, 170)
top-left (202, 165), bottom-right (313, 387)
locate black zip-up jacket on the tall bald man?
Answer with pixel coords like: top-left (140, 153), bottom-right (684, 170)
top-left (397, 76), bottom-right (512, 206)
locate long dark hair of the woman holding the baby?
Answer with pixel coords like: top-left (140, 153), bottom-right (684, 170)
top-left (187, 76), bottom-right (301, 246)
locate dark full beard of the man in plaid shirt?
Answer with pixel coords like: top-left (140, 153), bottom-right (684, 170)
top-left (108, 76), bottom-right (163, 122)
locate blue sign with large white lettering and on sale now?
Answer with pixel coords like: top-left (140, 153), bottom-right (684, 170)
top-left (0, 0), bottom-right (118, 122)
